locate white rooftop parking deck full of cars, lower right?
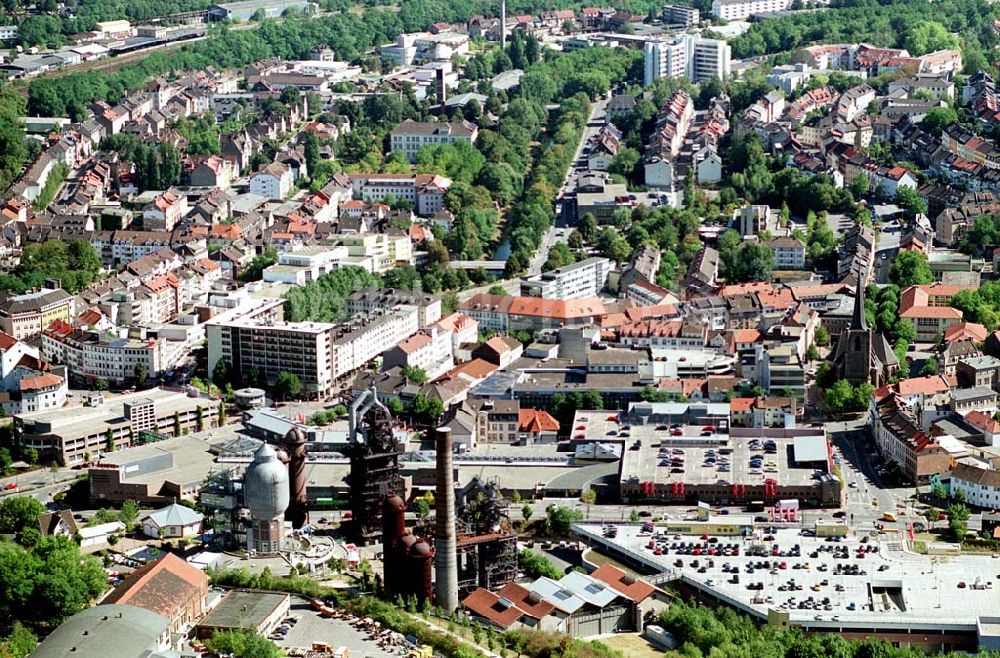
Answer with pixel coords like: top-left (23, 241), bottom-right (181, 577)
top-left (578, 525), bottom-right (1000, 632)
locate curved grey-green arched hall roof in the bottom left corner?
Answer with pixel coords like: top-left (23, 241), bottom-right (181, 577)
top-left (31, 605), bottom-right (171, 658)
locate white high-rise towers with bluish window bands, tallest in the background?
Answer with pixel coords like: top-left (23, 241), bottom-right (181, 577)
top-left (643, 34), bottom-right (732, 85)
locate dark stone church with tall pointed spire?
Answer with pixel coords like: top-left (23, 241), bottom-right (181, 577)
top-left (833, 281), bottom-right (899, 388)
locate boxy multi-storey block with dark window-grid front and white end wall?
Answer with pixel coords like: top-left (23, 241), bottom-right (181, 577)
top-left (205, 299), bottom-right (336, 396)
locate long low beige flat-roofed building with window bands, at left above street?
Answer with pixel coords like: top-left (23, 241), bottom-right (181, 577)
top-left (14, 388), bottom-right (219, 465)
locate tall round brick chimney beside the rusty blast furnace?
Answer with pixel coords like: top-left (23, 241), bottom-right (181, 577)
top-left (434, 427), bottom-right (458, 612)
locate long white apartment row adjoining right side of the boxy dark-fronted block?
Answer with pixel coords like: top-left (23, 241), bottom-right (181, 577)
top-left (332, 306), bottom-right (420, 378)
